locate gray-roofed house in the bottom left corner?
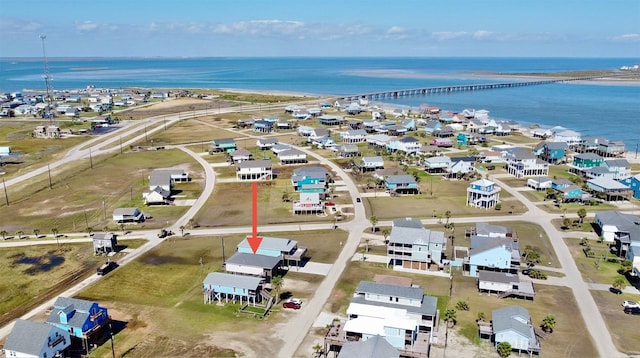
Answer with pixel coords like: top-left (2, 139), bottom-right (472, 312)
top-left (4, 319), bottom-right (71, 358)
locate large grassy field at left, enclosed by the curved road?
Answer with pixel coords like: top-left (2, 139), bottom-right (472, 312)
top-left (0, 150), bottom-right (202, 234)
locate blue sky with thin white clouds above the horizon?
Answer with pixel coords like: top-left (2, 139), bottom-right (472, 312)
top-left (0, 0), bottom-right (640, 58)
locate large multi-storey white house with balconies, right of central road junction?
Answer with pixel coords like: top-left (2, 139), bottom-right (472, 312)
top-left (387, 218), bottom-right (446, 271)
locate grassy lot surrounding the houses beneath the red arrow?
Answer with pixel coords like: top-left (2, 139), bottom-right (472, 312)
top-left (78, 230), bottom-right (340, 357)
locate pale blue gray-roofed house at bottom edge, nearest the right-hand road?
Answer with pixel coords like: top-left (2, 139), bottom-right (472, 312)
top-left (491, 306), bottom-right (541, 355)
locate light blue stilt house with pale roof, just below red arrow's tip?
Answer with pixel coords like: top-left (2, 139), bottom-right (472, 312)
top-left (202, 272), bottom-right (262, 306)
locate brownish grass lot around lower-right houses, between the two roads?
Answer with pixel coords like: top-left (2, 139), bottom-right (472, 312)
top-left (327, 261), bottom-right (596, 357)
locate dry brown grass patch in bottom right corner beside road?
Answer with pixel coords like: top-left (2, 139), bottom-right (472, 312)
top-left (591, 291), bottom-right (640, 356)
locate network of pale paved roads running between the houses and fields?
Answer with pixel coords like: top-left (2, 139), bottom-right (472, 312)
top-left (0, 106), bottom-right (636, 357)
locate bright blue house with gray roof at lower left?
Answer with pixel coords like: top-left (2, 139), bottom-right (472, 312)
top-left (47, 297), bottom-right (109, 339)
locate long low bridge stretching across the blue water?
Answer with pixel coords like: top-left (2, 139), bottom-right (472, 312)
top-left (338, 75), bottom-right (619, 101)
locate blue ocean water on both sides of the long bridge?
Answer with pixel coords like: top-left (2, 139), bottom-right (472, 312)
top-left (0, 57), bottom-right (640, 151)
